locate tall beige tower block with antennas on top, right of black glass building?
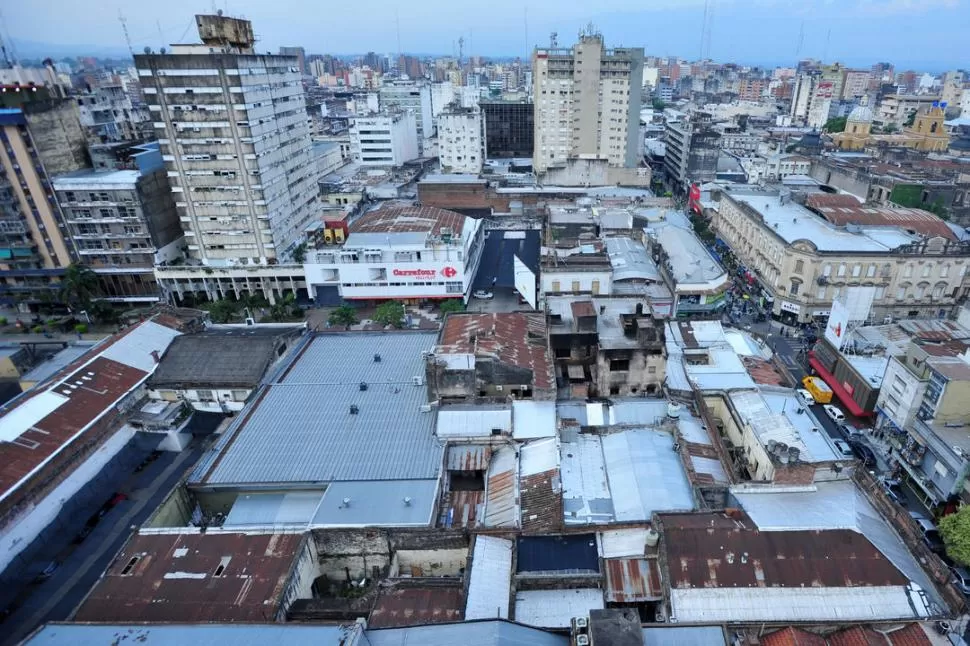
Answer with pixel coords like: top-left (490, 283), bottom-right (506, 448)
top-left (532, 31), bottom-right (643, 172)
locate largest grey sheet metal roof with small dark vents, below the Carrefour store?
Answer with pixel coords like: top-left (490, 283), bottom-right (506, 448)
top-left (190, 332), bottom-right (443, 485)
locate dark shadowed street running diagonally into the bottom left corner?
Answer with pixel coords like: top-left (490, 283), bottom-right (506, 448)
top-left (0, 441), bottom-right (203, 646)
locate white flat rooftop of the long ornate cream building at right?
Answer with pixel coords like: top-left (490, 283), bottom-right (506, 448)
top-left (726, 191), bottom-right (920, 252)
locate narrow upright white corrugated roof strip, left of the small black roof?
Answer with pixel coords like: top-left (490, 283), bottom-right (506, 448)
top-left (465, 535), bottom-right (512, 619)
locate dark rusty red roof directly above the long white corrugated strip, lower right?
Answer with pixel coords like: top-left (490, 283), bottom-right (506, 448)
top-left (663, 514), bottom-right (909, 589)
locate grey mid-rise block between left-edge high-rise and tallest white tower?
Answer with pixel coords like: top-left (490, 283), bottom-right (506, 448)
top-left (52, 149), bottom-right (183, 303)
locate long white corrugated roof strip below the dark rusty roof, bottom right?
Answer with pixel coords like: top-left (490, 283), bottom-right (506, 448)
top-left (670, 586), bottom-right (928, 623)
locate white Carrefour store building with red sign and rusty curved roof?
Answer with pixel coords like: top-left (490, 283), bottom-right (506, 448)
top-left (304, 204), bottom-right (484, 302)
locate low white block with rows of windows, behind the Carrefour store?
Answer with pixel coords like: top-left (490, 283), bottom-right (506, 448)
top-left (350, 111), bottom-right (420, 168)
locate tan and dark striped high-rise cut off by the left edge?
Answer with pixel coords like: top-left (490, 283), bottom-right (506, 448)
top-left (0, 85), bottom-right (90, 308)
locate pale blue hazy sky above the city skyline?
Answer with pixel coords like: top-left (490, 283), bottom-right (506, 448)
top-left (7, 0), bottom-right (970, 70)
